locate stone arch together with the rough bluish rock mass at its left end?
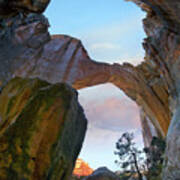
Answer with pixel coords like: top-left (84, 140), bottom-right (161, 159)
top-left (0, 14), bottom-right (171, 139)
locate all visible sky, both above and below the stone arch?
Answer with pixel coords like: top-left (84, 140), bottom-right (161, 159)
top-left (45, 0), bottom-right (145, 171)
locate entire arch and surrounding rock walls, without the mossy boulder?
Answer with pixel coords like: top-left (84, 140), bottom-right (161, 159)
top-left (0, 0), bottom-right (180, 180)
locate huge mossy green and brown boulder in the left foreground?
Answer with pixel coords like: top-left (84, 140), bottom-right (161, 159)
top-left (0, 78), bottom-right (87, 180)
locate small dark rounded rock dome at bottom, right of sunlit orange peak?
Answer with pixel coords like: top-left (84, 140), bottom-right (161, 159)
top-left (83, 167), bottom-right (120, 180)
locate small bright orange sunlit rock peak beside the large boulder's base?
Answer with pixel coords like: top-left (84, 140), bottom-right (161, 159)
top-left (73, 158), bottom-right (93, 177)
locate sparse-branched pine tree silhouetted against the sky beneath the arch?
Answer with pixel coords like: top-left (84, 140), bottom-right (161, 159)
top-left (115, 132), bottom-right (143, 180)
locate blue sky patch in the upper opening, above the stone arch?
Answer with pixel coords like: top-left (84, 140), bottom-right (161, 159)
top-left (45, 0), bottom-right (145, 62)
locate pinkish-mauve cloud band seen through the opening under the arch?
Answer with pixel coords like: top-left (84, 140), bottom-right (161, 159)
top-left (83, 97), bottom-right (140, 131)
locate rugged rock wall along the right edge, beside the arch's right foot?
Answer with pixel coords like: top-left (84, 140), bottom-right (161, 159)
top-left (129, 0), bottom-right (180, 180)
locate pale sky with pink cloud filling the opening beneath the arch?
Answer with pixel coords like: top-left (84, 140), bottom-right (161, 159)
top-left (76, 83), bottom-right (143, 171)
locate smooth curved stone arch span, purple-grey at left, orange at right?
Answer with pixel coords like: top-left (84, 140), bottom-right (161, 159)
top-left (11, 32), bottom-right (170, 137)
